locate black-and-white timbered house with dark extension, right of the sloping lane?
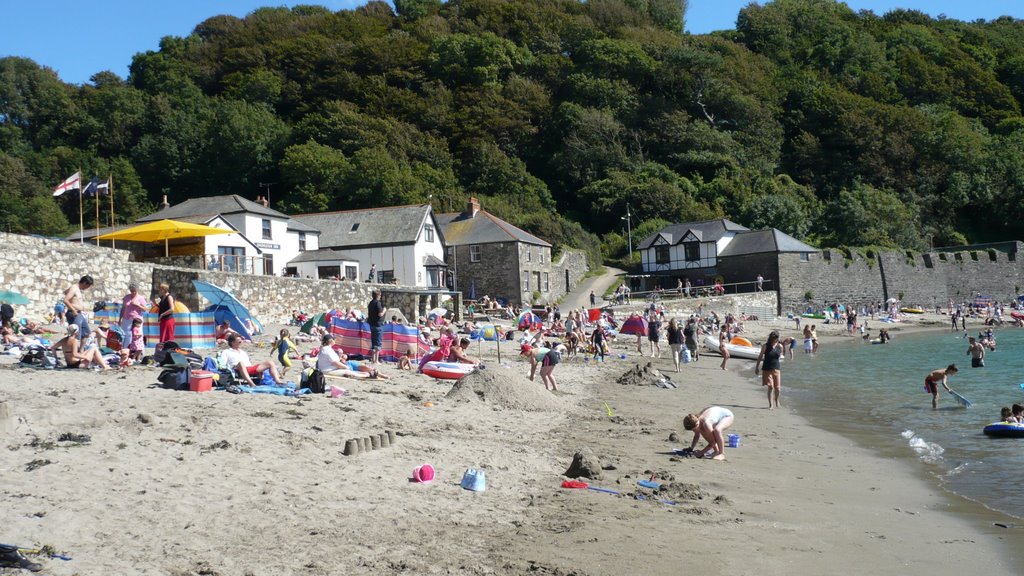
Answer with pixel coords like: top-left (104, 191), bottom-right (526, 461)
top-left (633, 218), bottom-right (818, 293)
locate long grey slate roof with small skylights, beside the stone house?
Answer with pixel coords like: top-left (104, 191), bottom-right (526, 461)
top-left (292, 204), bottom-right (441, 248)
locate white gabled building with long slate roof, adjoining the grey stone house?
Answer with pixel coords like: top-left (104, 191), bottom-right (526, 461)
top-left (289, 204), bottom-right (447, 288)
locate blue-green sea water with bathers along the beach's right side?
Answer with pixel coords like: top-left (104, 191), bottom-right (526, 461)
top-left (782, 329), bottom-right (1024, 518)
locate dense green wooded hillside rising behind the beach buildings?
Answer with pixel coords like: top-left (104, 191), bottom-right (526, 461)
top-left (0, 0), bottom-right (1024, 264)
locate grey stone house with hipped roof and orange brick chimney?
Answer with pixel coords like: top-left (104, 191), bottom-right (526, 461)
top-left (437, 198), bottom-right (557, 305)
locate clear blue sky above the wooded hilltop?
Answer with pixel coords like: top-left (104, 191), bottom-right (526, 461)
top-left (0, 0), bottom-right (1024, 84)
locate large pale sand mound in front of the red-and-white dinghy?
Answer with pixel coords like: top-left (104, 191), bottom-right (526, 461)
top-left (445, 368), bottom-right (564, 411)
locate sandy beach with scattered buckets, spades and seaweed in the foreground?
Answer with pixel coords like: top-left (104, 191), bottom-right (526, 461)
top-left (0, 309), bottom-right (1024, 576)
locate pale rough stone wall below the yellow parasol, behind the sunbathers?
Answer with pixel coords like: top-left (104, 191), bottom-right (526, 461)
top-left (0, 233), bottom-right (452, 323)
